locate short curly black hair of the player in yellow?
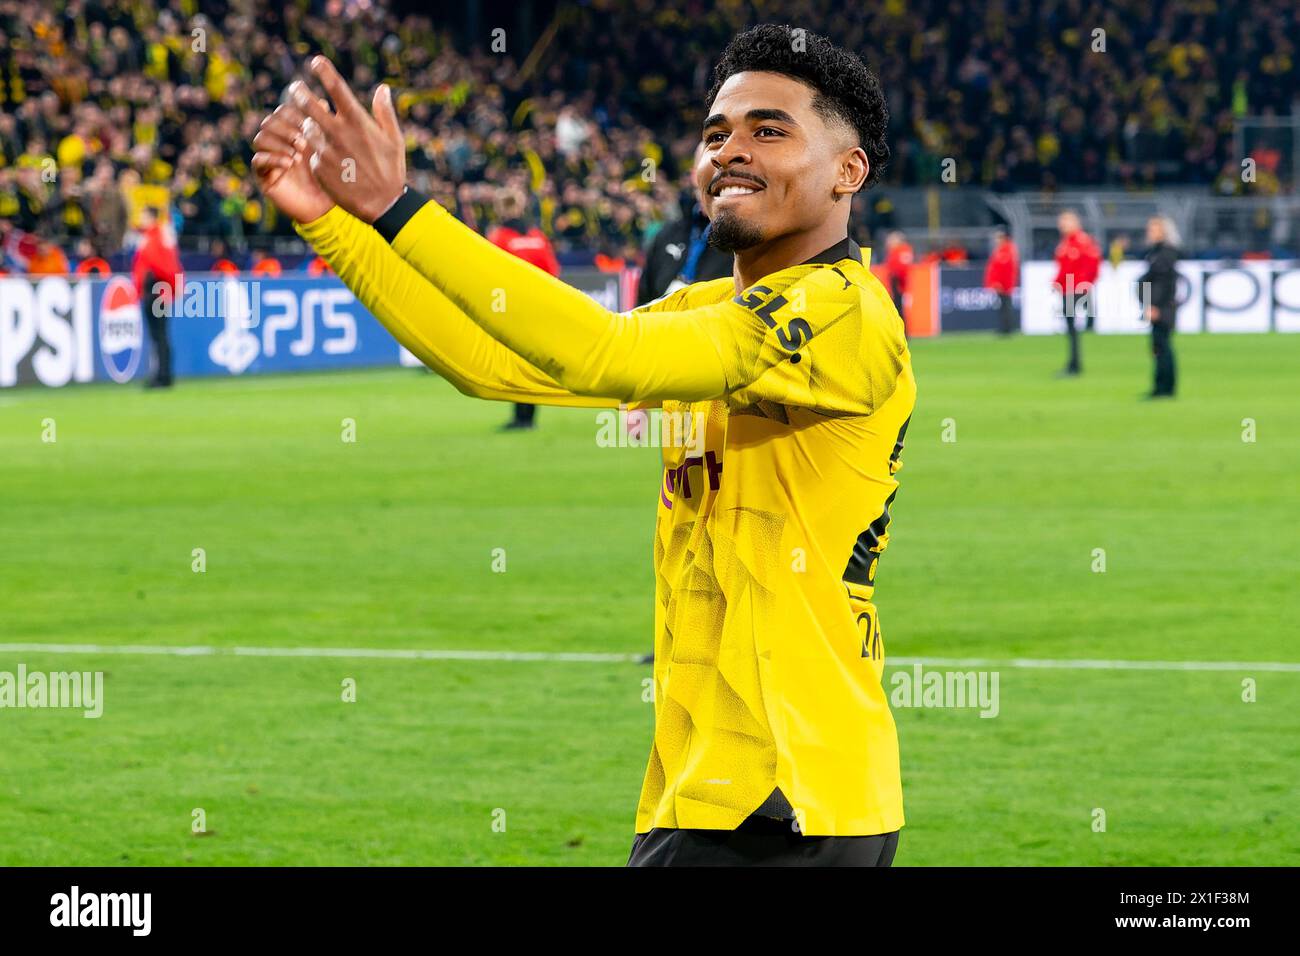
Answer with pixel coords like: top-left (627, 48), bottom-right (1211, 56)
top-left (705, 23), bottom-right (889, 189)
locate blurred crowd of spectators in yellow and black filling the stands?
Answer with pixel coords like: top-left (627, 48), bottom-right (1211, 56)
top-left (0, 0), bottom-right (1300, 269)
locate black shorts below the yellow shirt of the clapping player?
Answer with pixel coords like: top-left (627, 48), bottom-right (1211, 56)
top-left (628, 817), bottom-right (898, 866)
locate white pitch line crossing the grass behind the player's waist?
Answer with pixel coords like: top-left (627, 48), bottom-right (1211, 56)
top-left (0, 644), bottom-right (1300, 674)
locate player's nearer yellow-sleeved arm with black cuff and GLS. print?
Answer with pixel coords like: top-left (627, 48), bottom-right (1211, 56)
top-left (374, 190), bottom-right (906, 414)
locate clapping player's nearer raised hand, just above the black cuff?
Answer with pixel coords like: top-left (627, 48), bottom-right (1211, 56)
top-left (289, 56), bottom-right (406, 222)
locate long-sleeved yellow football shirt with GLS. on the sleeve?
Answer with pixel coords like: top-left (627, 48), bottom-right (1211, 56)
top-left (299, 201), bottom-right (915, 835)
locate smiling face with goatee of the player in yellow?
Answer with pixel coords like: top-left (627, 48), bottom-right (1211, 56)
top-left (696, 72), bottom-right (868, 252)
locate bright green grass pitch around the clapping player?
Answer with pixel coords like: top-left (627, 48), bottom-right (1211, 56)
top-left (0, 336), bottom-right (1300, 865)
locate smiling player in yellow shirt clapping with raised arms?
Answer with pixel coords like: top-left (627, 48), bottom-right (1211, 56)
top-left (254, 25), bottom-right (917, 865)
